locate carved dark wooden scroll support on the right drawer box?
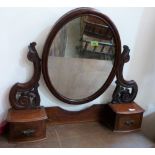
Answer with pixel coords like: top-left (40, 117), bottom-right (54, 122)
top-left (112, 45), bottom-right (138, 103)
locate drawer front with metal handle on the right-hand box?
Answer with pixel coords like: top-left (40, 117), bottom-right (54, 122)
top-left (115, 114), bottom-right (142, 131)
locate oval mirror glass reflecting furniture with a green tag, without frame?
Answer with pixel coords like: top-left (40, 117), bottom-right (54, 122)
top-left (48, 15), bottom-right (115, 99)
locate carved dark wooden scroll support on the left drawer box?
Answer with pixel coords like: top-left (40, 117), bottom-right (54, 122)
top-left (9, 42), bottom-right (41, 109)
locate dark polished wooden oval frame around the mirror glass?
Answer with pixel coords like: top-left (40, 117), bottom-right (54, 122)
top-left (42, 8), bottom-right (121, 105)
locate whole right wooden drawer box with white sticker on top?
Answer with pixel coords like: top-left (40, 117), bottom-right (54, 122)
top-left (103, 103), bottom-right (144, 132)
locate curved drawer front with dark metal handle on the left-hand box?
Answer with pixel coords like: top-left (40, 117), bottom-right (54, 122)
top-left (9, 121), bottom-right (46, 142)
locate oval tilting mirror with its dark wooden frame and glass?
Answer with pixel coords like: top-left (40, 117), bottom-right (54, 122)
top-left (43, 8), bottom-right (121, 104)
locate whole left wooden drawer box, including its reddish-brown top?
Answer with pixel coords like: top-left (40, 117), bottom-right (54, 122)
top-left (7, 108), bottom-right (47, 142)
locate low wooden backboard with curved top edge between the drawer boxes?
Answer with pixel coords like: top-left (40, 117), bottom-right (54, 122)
top-left (46, 105), bottom-right (104, 124)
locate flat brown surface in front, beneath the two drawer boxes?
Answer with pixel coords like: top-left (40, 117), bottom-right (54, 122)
top-left (0, 122), bottom-right (155, 147)
